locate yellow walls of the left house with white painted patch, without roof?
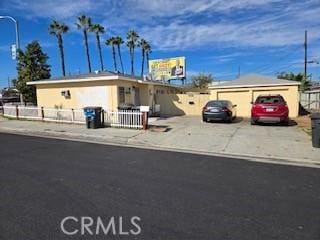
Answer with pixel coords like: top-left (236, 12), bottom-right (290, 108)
top-left (36, 80), bottom-right (178, 109)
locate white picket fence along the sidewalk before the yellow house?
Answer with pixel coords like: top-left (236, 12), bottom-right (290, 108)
top-left (0, 106), bottom-right (143, 129)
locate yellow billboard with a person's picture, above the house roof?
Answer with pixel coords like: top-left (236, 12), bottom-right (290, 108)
top-left (149, 57), bottom-right (186, 81)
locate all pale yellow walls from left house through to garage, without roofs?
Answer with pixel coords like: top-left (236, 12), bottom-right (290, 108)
top-left (36, 80), bottom-right (299, 117)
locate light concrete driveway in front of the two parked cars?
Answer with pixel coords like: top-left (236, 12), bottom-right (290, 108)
top-left (132, 116), bottom-right (320, 161)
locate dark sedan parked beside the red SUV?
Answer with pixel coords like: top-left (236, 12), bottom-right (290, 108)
top-left (202, 100), bottom-right (237, 122)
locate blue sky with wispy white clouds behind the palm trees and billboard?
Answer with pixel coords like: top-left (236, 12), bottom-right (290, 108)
top-left (0, 0), bottom-right (320, 87)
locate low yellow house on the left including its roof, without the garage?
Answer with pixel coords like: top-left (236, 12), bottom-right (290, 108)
top-left (27, 72), bottom-right (181, 114)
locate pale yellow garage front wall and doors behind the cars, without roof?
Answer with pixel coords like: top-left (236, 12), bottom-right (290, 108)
top-left (211, 86), bottom-right (299, 117)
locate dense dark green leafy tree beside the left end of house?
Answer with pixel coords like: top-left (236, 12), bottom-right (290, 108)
top-left (13, 41), bottom-right (51, 104)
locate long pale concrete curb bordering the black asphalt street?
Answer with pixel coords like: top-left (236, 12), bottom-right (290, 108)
top-left (0, 127), bottom-right (320, 168)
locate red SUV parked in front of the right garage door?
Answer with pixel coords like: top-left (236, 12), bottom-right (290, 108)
top-left (251, 95), bottom-right (289, 125)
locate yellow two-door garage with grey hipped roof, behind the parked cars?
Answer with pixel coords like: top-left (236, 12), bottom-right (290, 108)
top-left (209, 75), bottom-right (300, 117)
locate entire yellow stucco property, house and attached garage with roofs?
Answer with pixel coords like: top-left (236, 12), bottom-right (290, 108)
top-left (28, 72), bottom-right (299, 117)
